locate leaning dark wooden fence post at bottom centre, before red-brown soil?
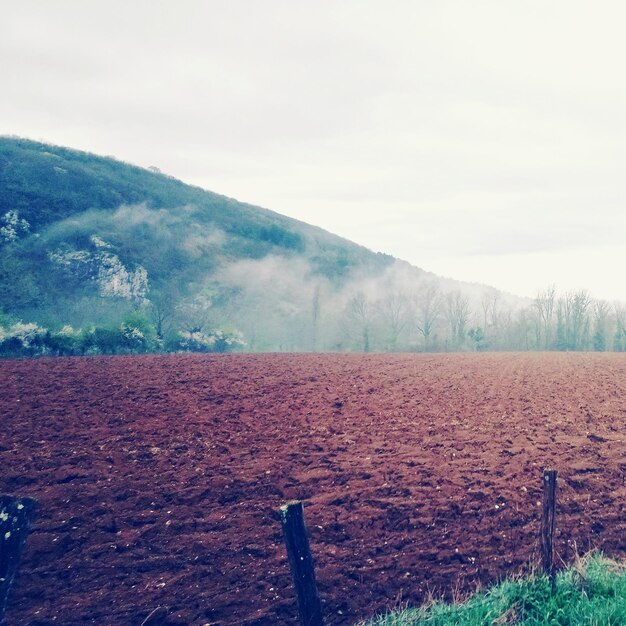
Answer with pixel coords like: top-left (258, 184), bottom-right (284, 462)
top-left (280, 500), bottom-right (324, 626)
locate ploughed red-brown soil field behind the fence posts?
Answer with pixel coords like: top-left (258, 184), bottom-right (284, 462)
top-left (0, 354), bottom-right (626, 626)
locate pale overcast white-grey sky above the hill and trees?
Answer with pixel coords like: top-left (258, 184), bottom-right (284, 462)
top-left (0, 0), bottom-right (626, 300)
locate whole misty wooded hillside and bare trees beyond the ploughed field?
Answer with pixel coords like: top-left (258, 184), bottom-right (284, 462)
top-left (0, 137), bottom-right (626, 355)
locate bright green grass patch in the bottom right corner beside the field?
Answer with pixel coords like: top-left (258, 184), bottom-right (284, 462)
top-left (360, 554), bottom-right (626, 626)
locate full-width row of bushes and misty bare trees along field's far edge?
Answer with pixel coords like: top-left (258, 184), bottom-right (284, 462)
top-left (0, 279), bottom-right (626, 357)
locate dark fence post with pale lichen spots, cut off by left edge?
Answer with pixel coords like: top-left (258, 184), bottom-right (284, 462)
top-left (0, 496), bottom-right (35, 622)
